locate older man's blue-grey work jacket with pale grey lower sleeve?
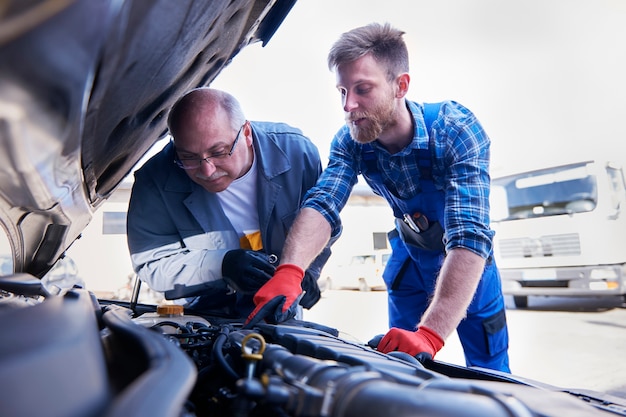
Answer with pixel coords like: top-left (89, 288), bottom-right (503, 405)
top-left (127, 122), bottom-right (330, 306)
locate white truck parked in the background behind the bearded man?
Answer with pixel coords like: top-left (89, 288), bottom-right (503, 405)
top-left (491, 161), bottom-right (626, 308)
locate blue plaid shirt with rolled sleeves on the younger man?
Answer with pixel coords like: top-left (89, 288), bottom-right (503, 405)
top-left (303, 101), bottom-right (493, 259)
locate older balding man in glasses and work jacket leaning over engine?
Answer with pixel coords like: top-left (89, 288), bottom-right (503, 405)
top-left (128, 88), bottom-right (330, 318)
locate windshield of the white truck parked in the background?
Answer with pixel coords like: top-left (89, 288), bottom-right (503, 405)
top-left (491, 163), bottom-right (597, 221)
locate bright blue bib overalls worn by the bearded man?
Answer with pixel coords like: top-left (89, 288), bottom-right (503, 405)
top-left (361, 126), bottom-right (510, 372)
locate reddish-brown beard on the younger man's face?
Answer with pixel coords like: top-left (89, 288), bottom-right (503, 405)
top-left (346, 95), bottom-right (396, 143)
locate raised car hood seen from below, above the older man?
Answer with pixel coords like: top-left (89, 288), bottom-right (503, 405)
top-left (0, 0), bottom-right (295, 277)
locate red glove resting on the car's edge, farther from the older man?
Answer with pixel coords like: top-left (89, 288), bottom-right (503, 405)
top-left (377, 326), bottom-right (444, 358)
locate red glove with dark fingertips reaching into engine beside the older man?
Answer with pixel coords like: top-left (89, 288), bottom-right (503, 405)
top-left (245, 264), bottom-right (304, 328)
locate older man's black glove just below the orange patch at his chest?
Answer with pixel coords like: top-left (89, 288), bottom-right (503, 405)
top-left (222, 249), bottom-right (276, 294)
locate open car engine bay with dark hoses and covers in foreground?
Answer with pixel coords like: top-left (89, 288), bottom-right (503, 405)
top-left (0, 284), bottom-right (626, 417)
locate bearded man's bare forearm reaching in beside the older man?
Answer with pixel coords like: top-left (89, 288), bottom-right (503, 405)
top-left (281, 207), bottom-right (331, 270)
